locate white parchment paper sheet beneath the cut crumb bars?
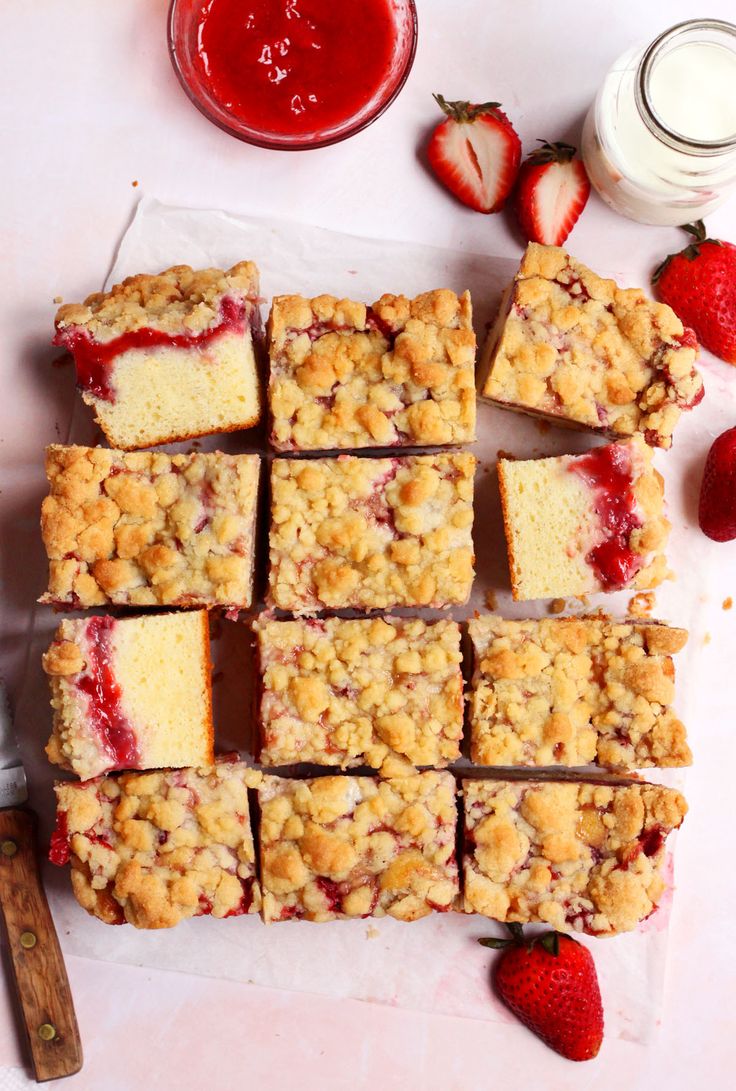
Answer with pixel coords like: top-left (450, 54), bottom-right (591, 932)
top-left (17, 199), bottom-right (734, 1042)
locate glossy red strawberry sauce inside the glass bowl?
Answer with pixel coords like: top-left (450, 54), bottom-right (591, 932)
top-left (189, 0), bottom-right (396, 136)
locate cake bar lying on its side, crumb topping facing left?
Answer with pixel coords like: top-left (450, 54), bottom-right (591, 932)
top-left (44, 610), bottom-right (214, 780)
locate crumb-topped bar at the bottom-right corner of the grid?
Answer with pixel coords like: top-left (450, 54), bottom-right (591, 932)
top-left (462, 780), bottom-right (687, 936)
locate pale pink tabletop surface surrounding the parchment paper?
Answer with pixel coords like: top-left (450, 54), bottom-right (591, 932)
top-left (0, 0), bottom-right (736, 1091)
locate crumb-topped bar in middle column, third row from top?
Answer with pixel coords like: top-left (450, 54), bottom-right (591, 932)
top-left (254, 618), bottom-right (463, 776)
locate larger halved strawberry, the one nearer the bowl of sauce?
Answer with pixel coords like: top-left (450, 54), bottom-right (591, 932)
top-left (427, 95), bottom-right (521, 212)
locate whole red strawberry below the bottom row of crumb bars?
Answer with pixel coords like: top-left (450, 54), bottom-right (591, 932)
top-left (479, 924), bottom-right (603, 1060)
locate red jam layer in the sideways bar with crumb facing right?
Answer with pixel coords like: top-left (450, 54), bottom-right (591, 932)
top-left (569, 444), bottom-right (643, 591)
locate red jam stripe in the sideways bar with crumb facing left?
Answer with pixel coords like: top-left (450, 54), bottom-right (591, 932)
top-left (76, 618), bottom-right (141, 769)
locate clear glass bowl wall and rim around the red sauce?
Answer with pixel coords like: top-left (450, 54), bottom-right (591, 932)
top-left (168, 0), bottom-right (418, 152)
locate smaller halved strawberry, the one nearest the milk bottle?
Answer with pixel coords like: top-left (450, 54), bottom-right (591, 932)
top-left (515, 141), bottom-right (590, 247)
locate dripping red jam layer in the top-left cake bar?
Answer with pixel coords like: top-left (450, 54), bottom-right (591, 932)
top-left (53, 296), bottom-right (248, 401)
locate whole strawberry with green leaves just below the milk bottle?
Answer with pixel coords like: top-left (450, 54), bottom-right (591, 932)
top-left (652, 219), bottom-right (736, 363)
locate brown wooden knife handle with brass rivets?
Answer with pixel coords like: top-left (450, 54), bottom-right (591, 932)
top-left (0, 807), bottom-right (82, 1083)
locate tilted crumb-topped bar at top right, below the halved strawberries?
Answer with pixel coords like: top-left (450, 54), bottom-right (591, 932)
top-left (481, 242), bottom-right (703, 447)
